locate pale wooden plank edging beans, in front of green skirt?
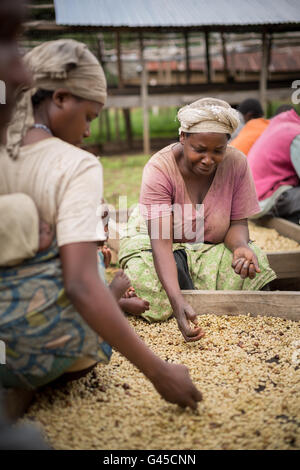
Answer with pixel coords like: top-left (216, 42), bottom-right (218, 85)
top-left (182, 290), bottom-right (300, 321)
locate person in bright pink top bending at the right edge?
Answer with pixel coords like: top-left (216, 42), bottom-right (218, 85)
top-left (248, 105), bottom-right (300, 224)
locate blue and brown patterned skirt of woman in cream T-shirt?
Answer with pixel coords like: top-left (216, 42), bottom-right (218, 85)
top-left (0, 240), bottom-right (112, 388)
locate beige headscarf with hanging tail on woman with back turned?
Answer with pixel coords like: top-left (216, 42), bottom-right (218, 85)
top-left (6, 39), bottom-right (107, 158)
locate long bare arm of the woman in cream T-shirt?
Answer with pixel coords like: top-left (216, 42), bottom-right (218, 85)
top-left (60, 242), bottom-right (202, 409)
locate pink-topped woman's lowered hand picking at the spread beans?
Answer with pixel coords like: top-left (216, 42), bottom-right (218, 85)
top-left (174, 302), bottom-right (205, 342)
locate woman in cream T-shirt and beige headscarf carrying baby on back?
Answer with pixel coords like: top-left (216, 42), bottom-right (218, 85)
top-left (0, 40), bottom-right (201, 408)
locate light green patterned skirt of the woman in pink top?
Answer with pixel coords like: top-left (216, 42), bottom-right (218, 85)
top-left (119, 210), bottom-right (276, 322)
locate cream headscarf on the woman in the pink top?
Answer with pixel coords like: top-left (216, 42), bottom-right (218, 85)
top-left (177, 98), bottom-right (240, 134)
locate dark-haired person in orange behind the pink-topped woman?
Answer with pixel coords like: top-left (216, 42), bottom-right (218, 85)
top-left (230, 99), bottom-right (269, 155)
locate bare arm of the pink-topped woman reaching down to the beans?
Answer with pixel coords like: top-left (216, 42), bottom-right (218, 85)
top-left (148, 216), bottom-right (204, 342)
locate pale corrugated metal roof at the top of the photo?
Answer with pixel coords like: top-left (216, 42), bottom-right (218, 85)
top-left (54, 0), bottom-right (300, 28)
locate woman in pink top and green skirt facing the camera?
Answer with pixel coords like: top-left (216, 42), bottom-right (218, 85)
top-left (119, 98), bottom-right (276, 341)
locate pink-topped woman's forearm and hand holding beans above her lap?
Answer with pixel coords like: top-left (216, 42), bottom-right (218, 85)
top-left (224, 219), bottom-right (260, 279)
